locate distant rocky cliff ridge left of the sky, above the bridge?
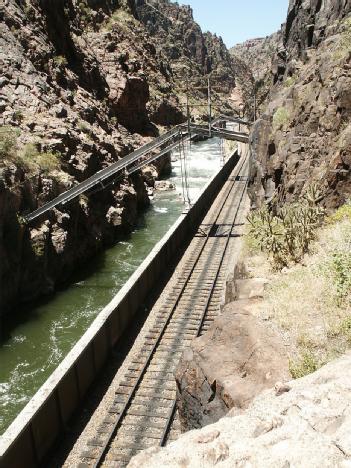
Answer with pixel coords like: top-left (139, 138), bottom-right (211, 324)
top-left (136, 0), bottom-right (235, 117)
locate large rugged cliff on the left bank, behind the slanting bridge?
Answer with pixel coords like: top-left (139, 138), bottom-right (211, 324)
top-left (0, 0), bottom-right (236, 315)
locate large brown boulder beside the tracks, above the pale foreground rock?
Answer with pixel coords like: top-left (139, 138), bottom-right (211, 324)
top-left (175, 303), bottom-right (290, 430)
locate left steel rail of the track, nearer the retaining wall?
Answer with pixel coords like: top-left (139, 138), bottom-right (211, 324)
top-left (92, 152), bottom-right (247, 468)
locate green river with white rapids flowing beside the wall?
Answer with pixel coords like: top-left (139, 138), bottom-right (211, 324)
top-left (0, 139), bottom-right (221, 434)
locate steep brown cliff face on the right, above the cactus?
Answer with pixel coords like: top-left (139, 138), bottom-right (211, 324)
top-left (251, 0), bottom-right (351, 208)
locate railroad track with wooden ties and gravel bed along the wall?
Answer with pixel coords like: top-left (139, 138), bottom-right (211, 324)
top-left (79, 153), bottom-right (248, 468)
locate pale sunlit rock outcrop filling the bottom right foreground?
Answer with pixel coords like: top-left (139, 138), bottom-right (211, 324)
top-left (128, 353), bottom-right (351, 468)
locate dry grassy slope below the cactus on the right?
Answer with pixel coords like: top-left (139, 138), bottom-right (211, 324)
top-left (246, 197), bottom-right (351, 378)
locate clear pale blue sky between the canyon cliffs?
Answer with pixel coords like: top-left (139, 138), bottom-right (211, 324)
top-left (178, 0), bottom-right (289, 47)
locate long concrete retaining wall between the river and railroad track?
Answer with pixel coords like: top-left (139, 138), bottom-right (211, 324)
top-left (0, 153), bottom-right (239, 468)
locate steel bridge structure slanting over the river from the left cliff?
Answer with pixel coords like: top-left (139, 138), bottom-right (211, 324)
top-left (25, 116), bottom-right (250, 222)
